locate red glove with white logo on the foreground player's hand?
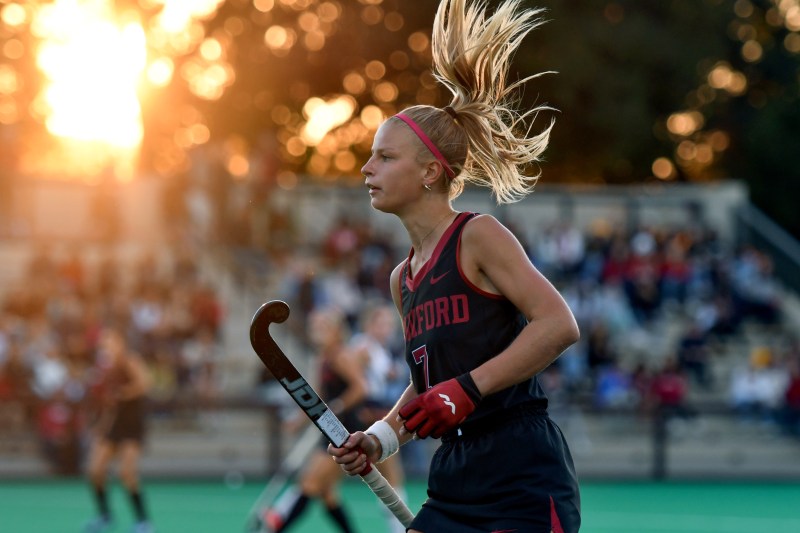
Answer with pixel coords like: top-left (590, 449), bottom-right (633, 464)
top-left (398, 373), bottom-right (481, 439)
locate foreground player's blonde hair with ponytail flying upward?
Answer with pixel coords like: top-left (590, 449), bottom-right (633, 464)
top-left (396, 0), bottom-right (553, 203)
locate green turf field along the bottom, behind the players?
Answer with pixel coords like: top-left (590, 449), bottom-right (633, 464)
top-left (0, 480), bottom-right (800, 533)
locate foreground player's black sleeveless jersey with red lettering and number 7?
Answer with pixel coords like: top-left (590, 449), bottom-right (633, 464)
top-left (400, 213), bottom-right (546, 421)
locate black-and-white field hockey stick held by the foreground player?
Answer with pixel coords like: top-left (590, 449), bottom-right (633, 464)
top-left (250, 300), bottom-right (414, 527)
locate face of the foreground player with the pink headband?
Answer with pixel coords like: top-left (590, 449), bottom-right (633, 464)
top-left (361, 121), bottom-right (425, 213)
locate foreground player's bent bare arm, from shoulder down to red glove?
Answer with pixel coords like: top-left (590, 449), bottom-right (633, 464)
top-left (460, 215), bottom-right (579, 396)
